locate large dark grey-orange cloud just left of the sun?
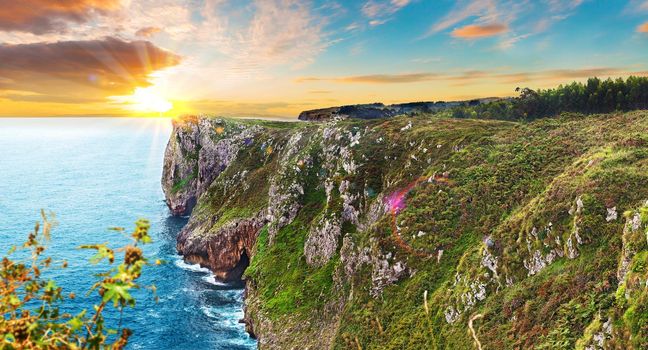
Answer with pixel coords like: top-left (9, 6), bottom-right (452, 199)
top-left (0, 37), bottom-right (180, 101)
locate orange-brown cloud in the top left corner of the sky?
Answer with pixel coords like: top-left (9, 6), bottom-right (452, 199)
top-left (0, 0), bottom-right (120, 34)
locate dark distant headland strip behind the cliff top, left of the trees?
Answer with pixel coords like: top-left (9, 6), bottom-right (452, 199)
top-left (299, 98), bottom-right (498, 121)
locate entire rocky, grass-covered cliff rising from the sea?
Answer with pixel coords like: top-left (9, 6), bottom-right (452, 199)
top-left (162, 112), bottom-right (648, 349)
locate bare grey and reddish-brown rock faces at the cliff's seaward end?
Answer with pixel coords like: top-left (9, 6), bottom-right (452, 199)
top-left (162, 117), bottom-right (265, 280)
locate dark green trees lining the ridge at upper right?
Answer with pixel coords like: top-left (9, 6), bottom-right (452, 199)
top-left (449, 76), bottom-right (648, 120)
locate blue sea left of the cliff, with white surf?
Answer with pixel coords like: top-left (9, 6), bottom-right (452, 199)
top-left (0, 118), bottom-right (256, 349)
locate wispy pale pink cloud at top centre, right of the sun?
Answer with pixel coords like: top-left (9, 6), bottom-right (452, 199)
top-left (196, 0), bottom-right (335, 73)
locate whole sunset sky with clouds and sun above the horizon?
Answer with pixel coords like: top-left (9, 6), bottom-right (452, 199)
top-left (0, 0), bottom-right (648, 118)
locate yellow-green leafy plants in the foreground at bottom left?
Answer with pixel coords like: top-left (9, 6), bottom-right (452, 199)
top-left (0, 212), bottom-right (159, 349)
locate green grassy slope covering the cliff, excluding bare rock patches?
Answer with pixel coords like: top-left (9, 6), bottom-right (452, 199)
top-left (196, 112), bottom-right (648, 349)
